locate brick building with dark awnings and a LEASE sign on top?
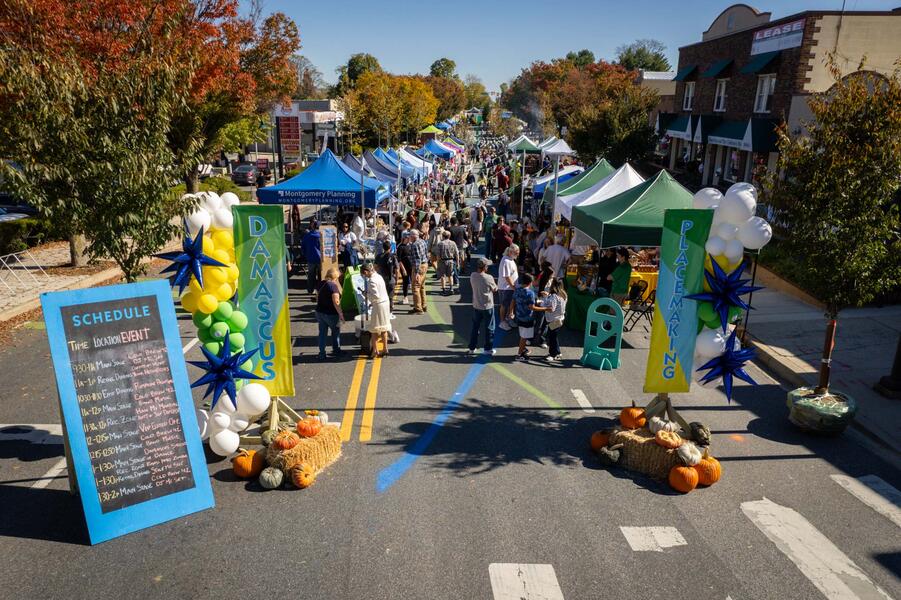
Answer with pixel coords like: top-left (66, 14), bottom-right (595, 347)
top-left (656, 4), bottom-right (901, 187)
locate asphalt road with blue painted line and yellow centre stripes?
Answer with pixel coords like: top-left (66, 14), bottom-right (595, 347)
top-left (0, 198), bottom-right (901, 600)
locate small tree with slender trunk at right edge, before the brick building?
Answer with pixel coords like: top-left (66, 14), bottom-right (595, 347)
top-left (764, 60), bottom-right (901, 393)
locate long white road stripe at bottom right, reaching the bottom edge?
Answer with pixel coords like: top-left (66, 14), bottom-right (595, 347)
top-left (741, 498), bottom-right (891, 600)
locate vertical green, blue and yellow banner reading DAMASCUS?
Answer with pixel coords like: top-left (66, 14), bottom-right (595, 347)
top-left (232, 205), bottom-right (294, 396)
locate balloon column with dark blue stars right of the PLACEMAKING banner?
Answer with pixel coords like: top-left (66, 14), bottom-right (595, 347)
top-left (689, 183), bottom-right (773, 400)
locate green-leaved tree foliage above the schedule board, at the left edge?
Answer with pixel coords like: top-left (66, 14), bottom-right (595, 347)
top-left (0, 44), bottom-right (196, 281)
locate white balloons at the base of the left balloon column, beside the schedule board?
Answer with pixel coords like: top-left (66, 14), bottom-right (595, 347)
top-left (197, 383), bottom-right (270, 456)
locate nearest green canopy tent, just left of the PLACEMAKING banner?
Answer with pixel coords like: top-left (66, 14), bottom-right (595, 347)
top-left (572, 171), bottom-right (692, 248)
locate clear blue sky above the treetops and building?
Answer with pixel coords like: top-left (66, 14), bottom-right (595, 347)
top-left (265, 0), bottom-right (901, 91)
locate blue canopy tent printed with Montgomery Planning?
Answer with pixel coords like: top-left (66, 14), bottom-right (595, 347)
top-left (257, 149), bottom-right (388, 208)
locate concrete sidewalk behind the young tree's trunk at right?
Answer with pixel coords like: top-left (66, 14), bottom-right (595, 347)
top-left (748, 288), bottom-right (901, 454)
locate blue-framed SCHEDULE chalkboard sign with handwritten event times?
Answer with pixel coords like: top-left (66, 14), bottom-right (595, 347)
top-left (41, 280), bottom-right (214, 544)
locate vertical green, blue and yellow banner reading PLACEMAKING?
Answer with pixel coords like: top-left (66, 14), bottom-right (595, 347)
top-left (644, 209), bottom-right (713, 393)
